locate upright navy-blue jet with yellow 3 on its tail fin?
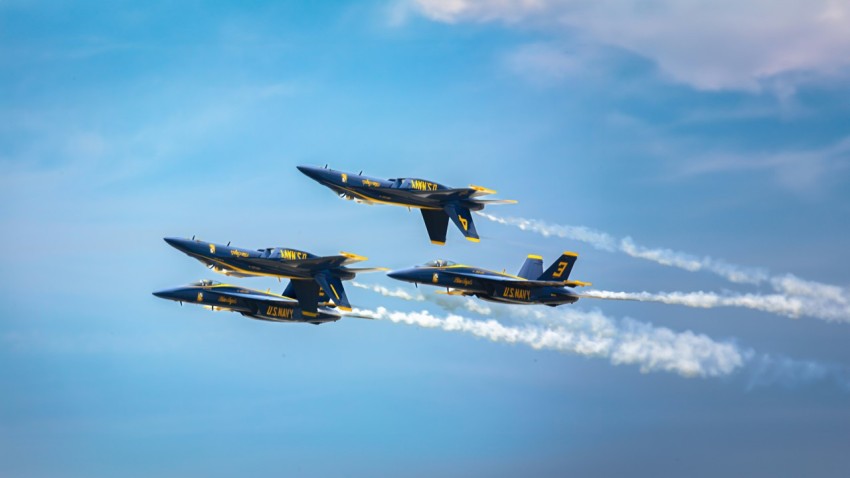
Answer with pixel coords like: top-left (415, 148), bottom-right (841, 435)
top-left (387, 252), bottom-right (591, 307)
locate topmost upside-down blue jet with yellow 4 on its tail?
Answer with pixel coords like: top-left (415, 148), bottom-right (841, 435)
top-left (298, 166), bottom-right (516, 245)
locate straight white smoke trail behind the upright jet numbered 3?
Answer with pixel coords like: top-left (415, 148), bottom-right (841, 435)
top-left (581, 290), bottom-right (805, 319)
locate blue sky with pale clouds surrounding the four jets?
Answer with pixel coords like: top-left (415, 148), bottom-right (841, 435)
top-left (0, 0), bottom-right (850, 477)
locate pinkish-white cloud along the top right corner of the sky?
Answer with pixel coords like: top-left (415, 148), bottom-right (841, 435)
top-left (416, 0), bottom-right (850, 91)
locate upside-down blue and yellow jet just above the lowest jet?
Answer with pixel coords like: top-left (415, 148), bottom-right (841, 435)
top-left (165, 237), bottom-right (387, 317)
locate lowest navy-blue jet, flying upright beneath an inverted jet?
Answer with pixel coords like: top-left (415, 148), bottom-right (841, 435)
top-left (153, 280), bottom-right (340, 324)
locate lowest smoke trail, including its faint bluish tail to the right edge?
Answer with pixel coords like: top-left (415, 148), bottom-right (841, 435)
top-left (352, 307), bottom-right (850, 391)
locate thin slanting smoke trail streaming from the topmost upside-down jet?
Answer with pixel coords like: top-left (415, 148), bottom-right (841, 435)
top-left (477, 212), bottom-right (850, 323)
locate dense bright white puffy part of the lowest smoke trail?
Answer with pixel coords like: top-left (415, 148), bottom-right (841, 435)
top-left (353, 307), bottom-right (746, 377)
